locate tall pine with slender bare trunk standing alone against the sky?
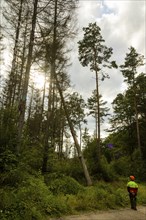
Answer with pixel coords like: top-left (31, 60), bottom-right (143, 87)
top-left (78, 23), bottom-right (117, 161)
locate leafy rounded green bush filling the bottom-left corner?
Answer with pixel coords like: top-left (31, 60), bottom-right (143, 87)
top-left (1, 177), bottom-right (48, 220)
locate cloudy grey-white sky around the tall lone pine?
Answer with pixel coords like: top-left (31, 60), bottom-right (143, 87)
top-left (69, 0), bottom-right (146, 137)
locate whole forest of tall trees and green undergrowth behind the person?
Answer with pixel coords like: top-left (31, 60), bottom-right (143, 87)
top-left (0, 0), bottom-right (146, 220)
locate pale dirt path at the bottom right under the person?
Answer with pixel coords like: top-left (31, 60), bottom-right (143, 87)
top-left (52, 206), bottom-right (146, 220)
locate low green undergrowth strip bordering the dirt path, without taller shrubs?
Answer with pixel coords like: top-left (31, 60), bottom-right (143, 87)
top-left (0, 175), bottom-right (146, 220)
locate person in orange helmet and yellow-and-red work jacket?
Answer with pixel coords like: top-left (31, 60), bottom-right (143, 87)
top-left (127, 176), bottom-right (138, 210)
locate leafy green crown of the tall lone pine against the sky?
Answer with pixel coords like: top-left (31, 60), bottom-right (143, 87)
top-left (78, 23), bottom-right (117, 72)
